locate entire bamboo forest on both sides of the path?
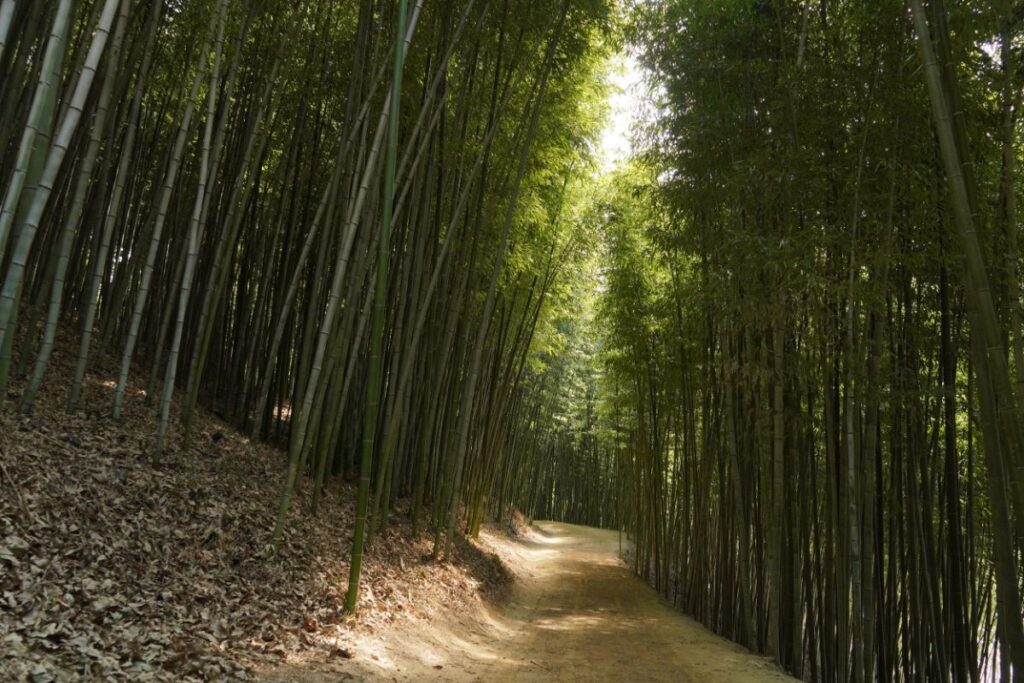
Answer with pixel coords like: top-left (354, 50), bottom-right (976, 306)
top-left (8, 0), bottom-right (1024, 682)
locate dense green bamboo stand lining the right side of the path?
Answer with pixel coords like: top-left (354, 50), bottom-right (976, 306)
top-left (519, 0), bottom-right (1024, 681)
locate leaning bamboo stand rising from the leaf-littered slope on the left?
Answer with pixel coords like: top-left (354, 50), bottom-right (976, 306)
top-left (0, 0), bottom-right (614, 608)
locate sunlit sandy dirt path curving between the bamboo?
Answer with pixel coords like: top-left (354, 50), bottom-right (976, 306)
top-left (260, 522), bottom-right (795, 683)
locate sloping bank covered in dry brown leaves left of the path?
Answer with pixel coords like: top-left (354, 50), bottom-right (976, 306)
top-left (0, 348), bottom-right (509, 683)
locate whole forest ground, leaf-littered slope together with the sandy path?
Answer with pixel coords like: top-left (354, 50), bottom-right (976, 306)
top-left (0, 349), bottom-right (787, 683)
